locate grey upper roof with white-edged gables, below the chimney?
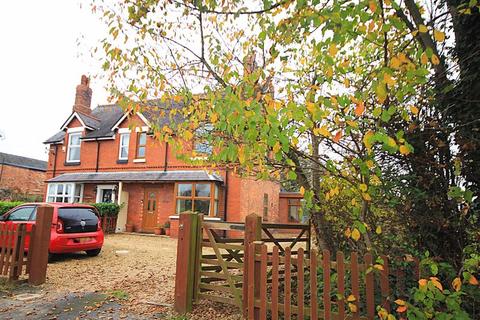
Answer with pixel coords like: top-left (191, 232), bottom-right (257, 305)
top-left (44, 100), bottom-right (183, 144)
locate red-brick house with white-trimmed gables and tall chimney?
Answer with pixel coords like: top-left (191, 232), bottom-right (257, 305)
top-left (45, 76), bottom-right (302, 232)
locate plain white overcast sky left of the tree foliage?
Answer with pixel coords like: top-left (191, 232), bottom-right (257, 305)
top-left (0, 0), bottom-right (107, 160)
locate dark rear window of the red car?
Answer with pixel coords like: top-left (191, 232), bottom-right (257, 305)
top-left (58, 207), bottom-right (98, 233)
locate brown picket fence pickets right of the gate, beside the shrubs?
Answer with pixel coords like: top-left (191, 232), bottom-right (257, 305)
top-left (246, 241), bottom-right (419, 320)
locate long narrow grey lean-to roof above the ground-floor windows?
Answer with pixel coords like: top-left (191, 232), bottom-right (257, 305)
top-left (48, 170), bottom-right (223, 182)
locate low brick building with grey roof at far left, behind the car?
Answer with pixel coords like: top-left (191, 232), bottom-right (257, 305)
top-left (0, 152), bottom-right (47, 200)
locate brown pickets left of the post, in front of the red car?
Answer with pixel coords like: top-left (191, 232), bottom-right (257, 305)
top-left (0, 223), bottom-right (35, 280)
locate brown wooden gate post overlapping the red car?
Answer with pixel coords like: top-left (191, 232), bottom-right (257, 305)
top-left (28, 205), bottom-right (53, 286)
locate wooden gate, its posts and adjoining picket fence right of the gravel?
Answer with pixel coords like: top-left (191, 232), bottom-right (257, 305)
top-left (175, 213), bottom-right (419, 320)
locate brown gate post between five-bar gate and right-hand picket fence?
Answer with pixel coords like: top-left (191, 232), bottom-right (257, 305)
top-left (242, 213), bottom-right (262, 318)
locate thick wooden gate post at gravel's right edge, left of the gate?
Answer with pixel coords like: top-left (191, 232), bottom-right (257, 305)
top-left (174, 212), bottom-right (199, 313)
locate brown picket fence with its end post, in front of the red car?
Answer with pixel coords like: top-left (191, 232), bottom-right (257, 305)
top-left (0, 206), bottom-right (53, 285)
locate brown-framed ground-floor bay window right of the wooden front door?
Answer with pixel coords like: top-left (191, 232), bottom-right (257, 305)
top-left (175, 182), bottom-right (218, 216)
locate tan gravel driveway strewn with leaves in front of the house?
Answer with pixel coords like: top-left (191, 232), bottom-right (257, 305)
top-left (0, 234), bottom-right (241, 320)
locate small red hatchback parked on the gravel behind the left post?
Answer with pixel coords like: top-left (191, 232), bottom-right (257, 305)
top-left (0, 203), bottom-right (104, 258)
